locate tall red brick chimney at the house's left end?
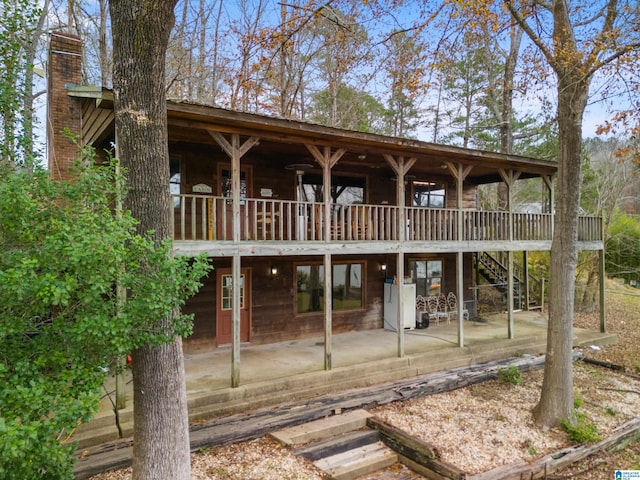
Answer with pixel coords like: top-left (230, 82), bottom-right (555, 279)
top-left (47, 32), bottom-right (82, 180)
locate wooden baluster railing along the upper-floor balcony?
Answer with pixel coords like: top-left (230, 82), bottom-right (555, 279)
top-left (173, 195), bottom-right (602, 242)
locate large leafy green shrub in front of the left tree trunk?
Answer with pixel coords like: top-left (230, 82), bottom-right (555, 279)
top-left (0, 159), bottom-right (208, 480)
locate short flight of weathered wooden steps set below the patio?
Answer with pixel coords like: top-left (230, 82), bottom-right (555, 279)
top-left (271, 410), bottom-right (398, 480)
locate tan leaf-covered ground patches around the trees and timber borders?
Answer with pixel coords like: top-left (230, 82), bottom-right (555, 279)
top-left (92, 284), bottom-right (640, 480)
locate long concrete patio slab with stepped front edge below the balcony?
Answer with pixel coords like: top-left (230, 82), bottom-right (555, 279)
top-left (73, 312), bottom-right (616, 449)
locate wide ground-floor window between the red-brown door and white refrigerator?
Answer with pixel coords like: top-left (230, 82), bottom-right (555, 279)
top-left (296, 263), bottom-right (364, 313)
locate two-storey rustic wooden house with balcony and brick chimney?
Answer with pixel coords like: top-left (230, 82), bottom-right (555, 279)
top-left (48, 35), bottom-right (603, 386)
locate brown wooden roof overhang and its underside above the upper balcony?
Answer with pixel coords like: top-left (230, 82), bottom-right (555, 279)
top-left (70, 89), bottom-right (557, 184)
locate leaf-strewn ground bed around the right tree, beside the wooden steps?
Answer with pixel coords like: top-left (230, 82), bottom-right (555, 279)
top-left (372, 363), bottom-right (640, 474)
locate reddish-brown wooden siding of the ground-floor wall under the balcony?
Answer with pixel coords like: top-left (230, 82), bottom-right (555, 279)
top-left (183, 254), bottom-right (473, 353)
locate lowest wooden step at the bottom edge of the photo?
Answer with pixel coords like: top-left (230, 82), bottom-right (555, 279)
top-left (314, 441), bottom-right (398, 480)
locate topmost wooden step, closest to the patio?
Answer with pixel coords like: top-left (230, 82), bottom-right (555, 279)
top-left (271, 410), bottom-right (371, 446)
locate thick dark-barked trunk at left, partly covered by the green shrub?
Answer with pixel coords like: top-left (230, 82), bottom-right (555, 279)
top-left (110, 0), bottom-right (190, 480)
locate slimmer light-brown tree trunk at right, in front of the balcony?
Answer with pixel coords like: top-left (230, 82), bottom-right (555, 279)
top-left (533, 69), bottom-right (589, 426)
